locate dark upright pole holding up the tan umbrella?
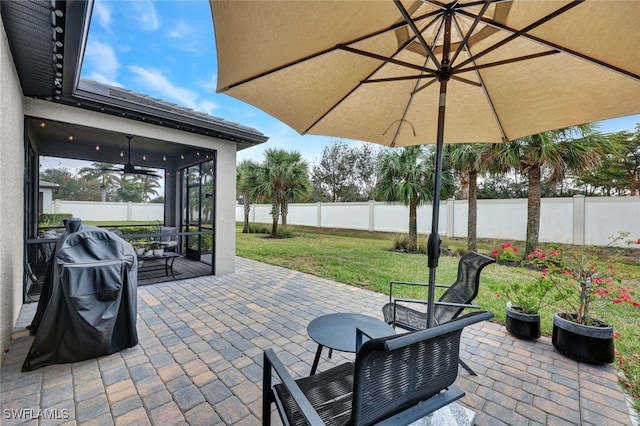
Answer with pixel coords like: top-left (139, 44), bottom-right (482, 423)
top-left (427, 13), bottom-right (451, 328)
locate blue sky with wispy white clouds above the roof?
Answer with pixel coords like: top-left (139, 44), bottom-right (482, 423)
top-left (57, 0), bottom-right (640, 172)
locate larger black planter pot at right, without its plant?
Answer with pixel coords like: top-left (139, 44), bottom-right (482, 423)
top-left (552, 313), bottom-right (614, 364)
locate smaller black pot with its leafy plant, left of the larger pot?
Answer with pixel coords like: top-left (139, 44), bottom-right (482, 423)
top-left (492, 242), bottom-right (555, 340)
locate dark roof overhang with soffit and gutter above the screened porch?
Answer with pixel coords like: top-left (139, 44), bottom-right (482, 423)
top-left (0, 0), bottom-right (268, 150)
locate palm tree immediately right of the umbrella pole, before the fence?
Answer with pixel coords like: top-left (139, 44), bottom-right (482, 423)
top-left (446, 143), bottom-right (487, 251)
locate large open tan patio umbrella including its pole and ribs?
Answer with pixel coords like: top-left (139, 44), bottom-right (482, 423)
top-left (210, 0), bottom-right (640, 327)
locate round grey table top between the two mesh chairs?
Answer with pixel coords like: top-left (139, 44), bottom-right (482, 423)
top-left (307, 313), bottom-right (396, 352)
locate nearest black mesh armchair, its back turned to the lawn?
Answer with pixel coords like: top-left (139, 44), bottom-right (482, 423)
top-left (262, 312), bottom-right (493, 425)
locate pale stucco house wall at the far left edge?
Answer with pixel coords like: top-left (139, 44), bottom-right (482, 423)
top-left (0, 20), bottom-right (24, 357)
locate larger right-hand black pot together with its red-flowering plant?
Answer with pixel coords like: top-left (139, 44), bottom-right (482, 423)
top-left (548, 232), bottom-right (640, 364)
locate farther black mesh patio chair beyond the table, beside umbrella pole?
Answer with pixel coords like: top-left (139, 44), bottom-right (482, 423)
top-left (382, 252), bottom-right (495, 376)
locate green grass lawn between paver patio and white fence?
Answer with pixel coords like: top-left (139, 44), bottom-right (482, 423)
top-left (236, 226), bottom-right (640, 409)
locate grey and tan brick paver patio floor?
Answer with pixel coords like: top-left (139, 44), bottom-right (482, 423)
top-left (0, 258), bottom-right (632, 426)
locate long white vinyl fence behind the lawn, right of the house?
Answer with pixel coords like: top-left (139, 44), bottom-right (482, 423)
top-left (236, 196), bottom-right (640, 245)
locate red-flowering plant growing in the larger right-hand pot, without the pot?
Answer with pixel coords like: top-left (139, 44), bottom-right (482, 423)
top-left (528, 232), bottom-right (640, 327)
